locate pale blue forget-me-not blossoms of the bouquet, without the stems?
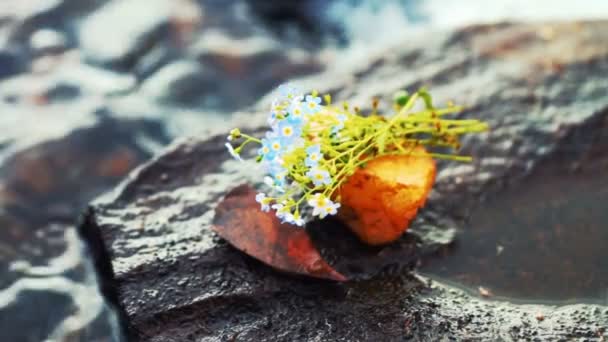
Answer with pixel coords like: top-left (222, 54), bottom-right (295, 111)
top-left (226, 84), bottom-right (346, 226)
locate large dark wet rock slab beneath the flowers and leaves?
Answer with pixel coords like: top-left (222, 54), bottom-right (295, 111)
top-left (80, 22), bottom-right (608, 341)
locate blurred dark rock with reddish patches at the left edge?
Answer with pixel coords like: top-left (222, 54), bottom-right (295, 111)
top-left (0, 113), bottom-right (165, 283)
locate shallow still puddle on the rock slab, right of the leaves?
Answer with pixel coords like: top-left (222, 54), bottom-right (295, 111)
top-left (421, 159), bottom-right (608, 304)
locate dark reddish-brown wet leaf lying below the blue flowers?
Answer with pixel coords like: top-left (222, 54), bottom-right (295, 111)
top-left (213, 185), bottom-right (347, 281)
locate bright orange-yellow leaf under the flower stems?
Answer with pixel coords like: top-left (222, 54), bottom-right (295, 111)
top-left (339, 147), bottom-right (435, 245)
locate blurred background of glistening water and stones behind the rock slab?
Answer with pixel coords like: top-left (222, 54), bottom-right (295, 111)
top-left (0, 0), bottom-right (608, 341)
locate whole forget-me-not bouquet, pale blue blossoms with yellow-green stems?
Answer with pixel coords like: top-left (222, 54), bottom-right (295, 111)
top-left (226, 84), bottom-right (486, 226)
